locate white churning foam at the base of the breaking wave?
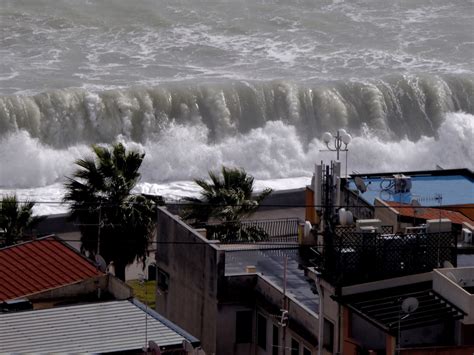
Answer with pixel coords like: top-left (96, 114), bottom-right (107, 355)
top-left (0, 113), bottom-right (474, 214)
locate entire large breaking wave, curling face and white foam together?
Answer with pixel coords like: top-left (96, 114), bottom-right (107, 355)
top-left (0, 76), bottom-right (474, 190)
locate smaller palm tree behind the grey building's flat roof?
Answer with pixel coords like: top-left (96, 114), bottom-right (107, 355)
top-left (182, 166), bottom-right (272, 241)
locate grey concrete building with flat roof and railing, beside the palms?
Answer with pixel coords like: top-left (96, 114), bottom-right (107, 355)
top-left (156, 207), bottom-right (318, 355)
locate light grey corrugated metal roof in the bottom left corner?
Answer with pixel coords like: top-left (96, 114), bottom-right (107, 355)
top-left (0, 301), bottom-right (197, 354)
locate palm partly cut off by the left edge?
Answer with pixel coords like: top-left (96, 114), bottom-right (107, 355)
top-left (0, 195), bottom-right (43, 246)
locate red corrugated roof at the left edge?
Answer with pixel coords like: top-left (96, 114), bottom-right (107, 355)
top-left (0, 237), bottom-right (102, 302)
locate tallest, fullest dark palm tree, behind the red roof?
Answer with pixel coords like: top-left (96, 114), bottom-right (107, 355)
top-left (64, 143), bottom-right (156, 280)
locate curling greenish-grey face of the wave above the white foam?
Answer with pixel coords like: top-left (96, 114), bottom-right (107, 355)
top-left (0, 75), bottom-right (474, 149)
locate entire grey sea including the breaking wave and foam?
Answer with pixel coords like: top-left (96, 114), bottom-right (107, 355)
top-left (0, 0), bottom-right (474, 213)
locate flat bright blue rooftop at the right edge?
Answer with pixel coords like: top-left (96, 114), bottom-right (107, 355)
top-left (349, 169), bottom-right (474, 207)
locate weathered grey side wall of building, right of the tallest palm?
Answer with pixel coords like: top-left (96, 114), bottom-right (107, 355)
top-left (156, 208), bottom-right (225, 355)
